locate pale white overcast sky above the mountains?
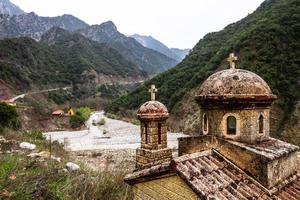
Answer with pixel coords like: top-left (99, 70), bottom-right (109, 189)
top-left (11, 0), bottom-right (263, 48)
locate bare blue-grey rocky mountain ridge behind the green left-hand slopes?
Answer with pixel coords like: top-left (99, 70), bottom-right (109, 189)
top-left (0, 7), bottom-right (178, 74)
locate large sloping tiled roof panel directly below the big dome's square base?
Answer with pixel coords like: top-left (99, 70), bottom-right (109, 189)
top-left (171, 150), bottom-right (267, 199)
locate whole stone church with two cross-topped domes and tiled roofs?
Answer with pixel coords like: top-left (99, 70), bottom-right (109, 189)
top-left (125, 54), bottom-right (300, 200)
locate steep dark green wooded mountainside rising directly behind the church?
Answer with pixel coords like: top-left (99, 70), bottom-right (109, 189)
top-left (106, 0), bottom-right (300, 141)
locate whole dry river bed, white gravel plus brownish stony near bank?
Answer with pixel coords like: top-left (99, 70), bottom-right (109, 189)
top-left (44, 111), bottom-right (185, 171)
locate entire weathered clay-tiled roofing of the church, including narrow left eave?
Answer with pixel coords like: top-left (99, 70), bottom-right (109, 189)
top-left (125, 150), bottom-right (300, 200)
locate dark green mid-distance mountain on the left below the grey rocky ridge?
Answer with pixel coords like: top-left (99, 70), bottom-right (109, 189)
top-left (0, 28), bottom-right (145, 91)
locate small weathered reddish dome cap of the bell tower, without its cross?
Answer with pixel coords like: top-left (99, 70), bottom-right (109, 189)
top-left (137, 101), bottom-right (169, 118)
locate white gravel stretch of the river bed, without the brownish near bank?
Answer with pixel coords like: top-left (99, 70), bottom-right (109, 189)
top-left (44, 111), bottom-right (185, 151)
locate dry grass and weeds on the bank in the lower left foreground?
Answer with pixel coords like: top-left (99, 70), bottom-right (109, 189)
top-left (0, 130), bottom-right (132, 200)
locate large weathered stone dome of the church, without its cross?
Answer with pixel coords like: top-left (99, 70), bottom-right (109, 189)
top-left (196, 68), bottom-right (276, 101)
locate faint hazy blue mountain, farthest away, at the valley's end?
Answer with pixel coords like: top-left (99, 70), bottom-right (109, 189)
top-left (130, 34), bottom-right (182, 62)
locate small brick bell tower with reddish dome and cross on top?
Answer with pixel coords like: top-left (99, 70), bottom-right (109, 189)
top-left (136, 85), bottom-right (172, 169)
